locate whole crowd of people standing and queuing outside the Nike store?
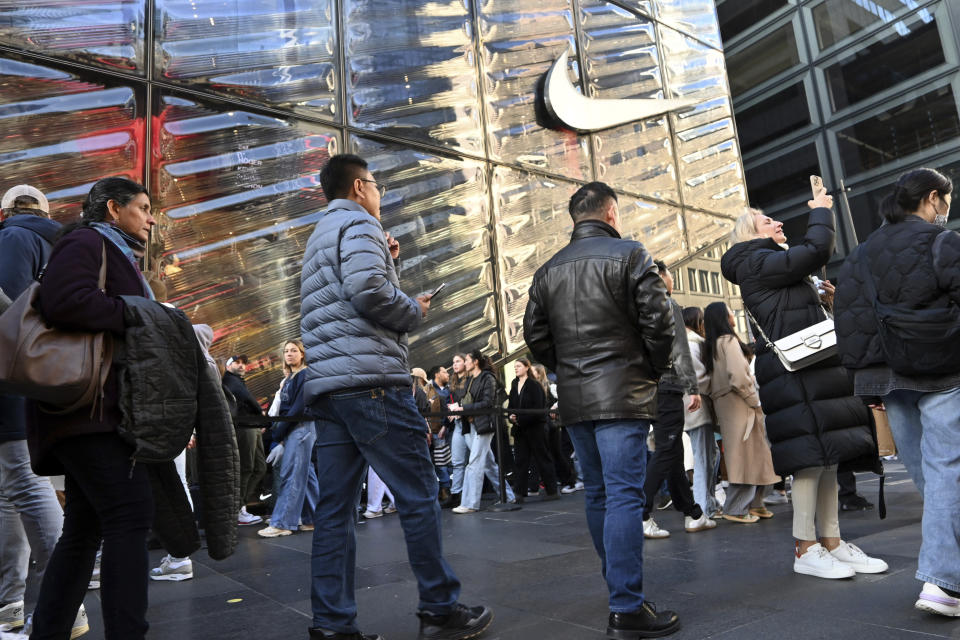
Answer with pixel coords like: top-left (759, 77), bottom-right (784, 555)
top-left (0, 154), bottom-right (960, 640)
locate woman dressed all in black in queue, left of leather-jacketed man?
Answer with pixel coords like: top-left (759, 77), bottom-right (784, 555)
top-left (507, 358), bottom-right (560, 502)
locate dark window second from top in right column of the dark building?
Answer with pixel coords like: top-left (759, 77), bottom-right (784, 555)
top-left (824, 12), bottom-right (944, 111)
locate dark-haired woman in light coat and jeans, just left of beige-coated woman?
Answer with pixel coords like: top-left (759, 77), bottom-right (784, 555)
top-left (683, 307), bottom-right (720, 518)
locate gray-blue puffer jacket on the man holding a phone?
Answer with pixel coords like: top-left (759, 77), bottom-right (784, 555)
top-left (300, 199), bottom-right (421, 406)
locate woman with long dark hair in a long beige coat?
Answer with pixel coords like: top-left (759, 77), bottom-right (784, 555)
top-left (702, 302), bottom-right (780, 524)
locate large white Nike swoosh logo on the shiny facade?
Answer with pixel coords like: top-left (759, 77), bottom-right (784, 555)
top-left (543, 51), bottom-right (697, 133)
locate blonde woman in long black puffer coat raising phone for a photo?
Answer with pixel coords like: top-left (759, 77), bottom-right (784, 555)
top-left (720, 190), bottom-right (887, 578)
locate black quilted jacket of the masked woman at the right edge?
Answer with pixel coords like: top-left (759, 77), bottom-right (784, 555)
top-left (834, 216), bottom-right (960, 369)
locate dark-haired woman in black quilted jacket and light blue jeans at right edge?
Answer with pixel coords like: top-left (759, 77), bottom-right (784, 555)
top-left (835, 169), bottom-right (960, 616)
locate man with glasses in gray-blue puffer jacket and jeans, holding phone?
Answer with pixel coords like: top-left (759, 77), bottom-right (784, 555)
top-left (300, 154), bottom-right (493, 640)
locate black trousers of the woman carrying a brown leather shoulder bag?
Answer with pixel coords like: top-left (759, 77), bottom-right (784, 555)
top-left (30, 433), bottom-right (153, 640)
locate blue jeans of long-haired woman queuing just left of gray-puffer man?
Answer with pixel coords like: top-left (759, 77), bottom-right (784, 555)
top-left (270, 422), bottom-right (320, 531)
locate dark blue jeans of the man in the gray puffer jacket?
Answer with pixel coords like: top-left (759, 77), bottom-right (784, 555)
top-left (310, 387), bottom-right (460, 633)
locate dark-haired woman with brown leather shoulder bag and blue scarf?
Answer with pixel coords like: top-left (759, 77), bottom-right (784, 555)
top-left (28, 178), bottom-right (156, 639)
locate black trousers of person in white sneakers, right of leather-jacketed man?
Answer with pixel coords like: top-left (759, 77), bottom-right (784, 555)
top-left (643, 390), bottom-right (703, 520)
